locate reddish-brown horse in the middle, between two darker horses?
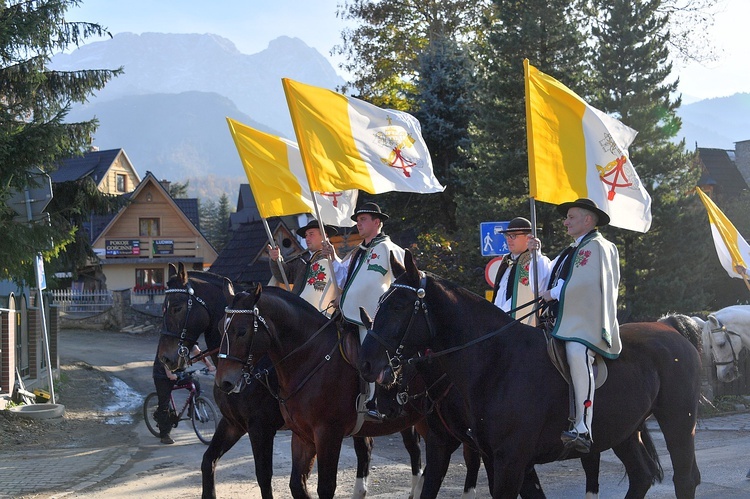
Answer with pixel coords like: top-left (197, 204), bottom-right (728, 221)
top-left (216, 285), bottom-right (484, 498)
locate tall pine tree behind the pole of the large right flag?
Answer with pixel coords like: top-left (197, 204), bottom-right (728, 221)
top-left (458, 0), bottom-right (589, 282)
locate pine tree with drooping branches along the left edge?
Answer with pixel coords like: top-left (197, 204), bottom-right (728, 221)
top-left (0, 0), bottom-right (121, 280)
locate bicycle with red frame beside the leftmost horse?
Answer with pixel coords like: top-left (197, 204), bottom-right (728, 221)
top-left (143, 369), bottom-right (218, 445)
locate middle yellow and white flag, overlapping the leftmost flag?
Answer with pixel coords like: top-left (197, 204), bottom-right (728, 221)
top-left (282, 78), bottom-right (445, 194)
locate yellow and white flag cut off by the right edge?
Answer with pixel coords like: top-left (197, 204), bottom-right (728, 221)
top-left (695, 187), bottom-right (750, 278)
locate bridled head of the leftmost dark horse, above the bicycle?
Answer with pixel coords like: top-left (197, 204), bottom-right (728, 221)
top-left (157, 263), bottom-right (228, 370)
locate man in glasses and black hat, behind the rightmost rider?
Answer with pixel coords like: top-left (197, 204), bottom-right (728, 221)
top-left (492, 217), bottom-right (550, 326)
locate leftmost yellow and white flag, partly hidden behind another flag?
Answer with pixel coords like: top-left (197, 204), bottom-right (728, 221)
top-left (227, 118), bottom-right (358, 227)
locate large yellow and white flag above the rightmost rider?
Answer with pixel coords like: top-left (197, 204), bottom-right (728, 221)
top-left (523, 59), bottom-right (651, 232)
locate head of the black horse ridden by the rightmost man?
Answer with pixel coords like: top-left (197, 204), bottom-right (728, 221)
top-left (358, 250), bottom-right (431, 386)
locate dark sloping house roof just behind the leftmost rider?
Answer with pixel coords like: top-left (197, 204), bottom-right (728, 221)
top-left (209, 218), bottom-right (296, 284)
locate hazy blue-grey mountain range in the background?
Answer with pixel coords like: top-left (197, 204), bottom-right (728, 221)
top-left (51, 33), bottom-right (750, 204)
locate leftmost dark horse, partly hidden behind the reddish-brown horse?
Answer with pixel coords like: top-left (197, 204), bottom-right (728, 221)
top-left (158, 264), bottom-right (428, 499)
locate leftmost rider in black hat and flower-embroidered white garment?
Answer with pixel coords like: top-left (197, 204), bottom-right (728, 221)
top-left (268, 220), bottom-right (338, 317)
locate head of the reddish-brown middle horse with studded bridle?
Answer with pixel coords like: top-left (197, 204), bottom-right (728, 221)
top-left (215, 282), bottom-right (270, 393)
